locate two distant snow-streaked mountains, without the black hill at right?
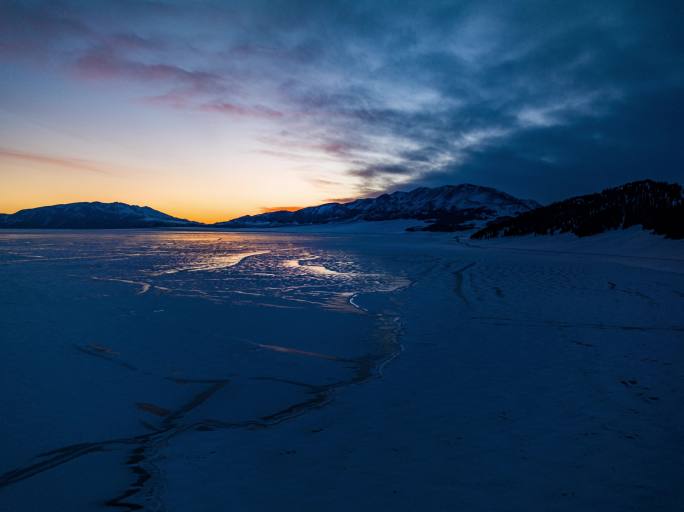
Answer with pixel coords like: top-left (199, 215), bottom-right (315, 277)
top-left (0, 185), bottom-right (539, 229)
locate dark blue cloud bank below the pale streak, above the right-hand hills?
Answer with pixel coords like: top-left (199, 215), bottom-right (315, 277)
top-left (428, 83), bottom-right (684, 202)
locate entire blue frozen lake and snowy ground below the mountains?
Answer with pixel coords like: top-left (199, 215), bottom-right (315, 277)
top-left (0, 229), bottom-right (684, 512)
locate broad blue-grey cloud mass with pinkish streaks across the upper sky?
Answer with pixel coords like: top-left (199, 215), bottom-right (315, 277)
top-left (0, 0), bottom-right (684, 200)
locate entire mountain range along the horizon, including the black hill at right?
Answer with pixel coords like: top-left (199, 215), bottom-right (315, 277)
top-left (0, 180), bottom-right (684, 239)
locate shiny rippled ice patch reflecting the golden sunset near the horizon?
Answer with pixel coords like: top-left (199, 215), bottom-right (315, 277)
top-left (0, 231), bottom-right (408, 312)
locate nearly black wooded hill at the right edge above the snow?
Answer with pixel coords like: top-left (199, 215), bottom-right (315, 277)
top-left (472, 180), bottom-right (684, 239)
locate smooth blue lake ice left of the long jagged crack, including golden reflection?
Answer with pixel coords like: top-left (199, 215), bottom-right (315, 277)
top-left (0, 231), bottom-right (404, 510)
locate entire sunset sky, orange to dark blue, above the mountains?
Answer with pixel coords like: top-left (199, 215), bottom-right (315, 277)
top-left (0, 0), bottom-right (684, 222)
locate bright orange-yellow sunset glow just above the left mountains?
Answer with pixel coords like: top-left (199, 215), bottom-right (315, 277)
top-left (0, 148), bottom-right (352, 223)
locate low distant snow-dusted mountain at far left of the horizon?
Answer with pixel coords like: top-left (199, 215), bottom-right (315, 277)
top-left (0, 202), bottom-right (200, 229)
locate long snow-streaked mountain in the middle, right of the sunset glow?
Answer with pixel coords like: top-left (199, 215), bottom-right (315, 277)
top-left (216, 184), bottom-right (539, 228)
